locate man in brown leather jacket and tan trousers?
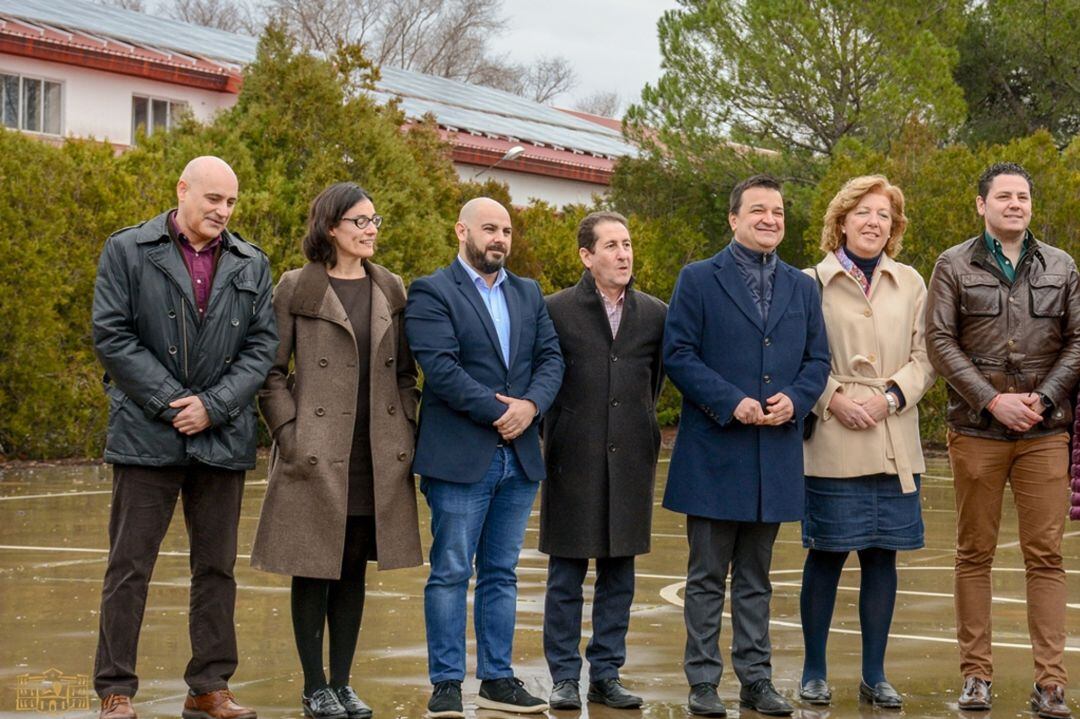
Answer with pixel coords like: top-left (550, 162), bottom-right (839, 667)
top-left (927, 163), bottom-right (1080, 719)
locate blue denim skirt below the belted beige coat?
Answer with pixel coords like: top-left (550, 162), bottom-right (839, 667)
top-left (802, 474), bottom-right (923, 552)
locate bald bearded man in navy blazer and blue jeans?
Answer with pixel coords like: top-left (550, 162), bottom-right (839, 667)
top-left (405, 198), bottom-right (563, 717)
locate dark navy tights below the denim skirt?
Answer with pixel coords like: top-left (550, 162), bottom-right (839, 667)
top-left (799, 547), bottom-right (896, 687)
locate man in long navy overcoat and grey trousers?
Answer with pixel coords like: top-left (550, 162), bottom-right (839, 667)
top-left (663, 175), bottom-right (829, 717)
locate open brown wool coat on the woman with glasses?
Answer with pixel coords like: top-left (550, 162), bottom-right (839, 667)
top-left (252, 261), bottom-right (422, 579)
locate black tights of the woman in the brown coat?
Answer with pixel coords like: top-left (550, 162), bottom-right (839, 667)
top-left (292, 517), bottom-right (375, 696)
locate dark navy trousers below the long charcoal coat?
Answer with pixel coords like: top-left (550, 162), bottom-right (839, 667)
top-left (543, 556), bottom-right (634, 683)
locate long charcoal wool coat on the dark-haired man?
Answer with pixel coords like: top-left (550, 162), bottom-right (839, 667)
top-left (540, 271), bottom-right (667, 558)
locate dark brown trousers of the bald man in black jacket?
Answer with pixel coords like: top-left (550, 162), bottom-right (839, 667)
top-left (94, 464), bottom-right (244, 697)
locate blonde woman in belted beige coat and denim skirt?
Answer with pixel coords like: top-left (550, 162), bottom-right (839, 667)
top-left (799, 175), bottom-right (934, 708)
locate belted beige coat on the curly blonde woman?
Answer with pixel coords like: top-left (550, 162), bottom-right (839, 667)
top-left (804, 253), bottom-right (935, 492)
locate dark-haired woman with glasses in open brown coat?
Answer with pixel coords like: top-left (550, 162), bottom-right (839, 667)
top-left (252, 182), bottom-right (422, 719)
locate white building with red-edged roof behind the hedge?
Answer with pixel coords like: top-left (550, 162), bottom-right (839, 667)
top-left (0, 0), bottom-right (636, 206)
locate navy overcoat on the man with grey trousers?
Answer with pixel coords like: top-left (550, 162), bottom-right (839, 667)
top-left (664, 243), bottom-right (829, 521)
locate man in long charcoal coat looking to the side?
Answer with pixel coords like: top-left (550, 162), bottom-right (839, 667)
top-left (540, 213), bottom-right (667, 709)
